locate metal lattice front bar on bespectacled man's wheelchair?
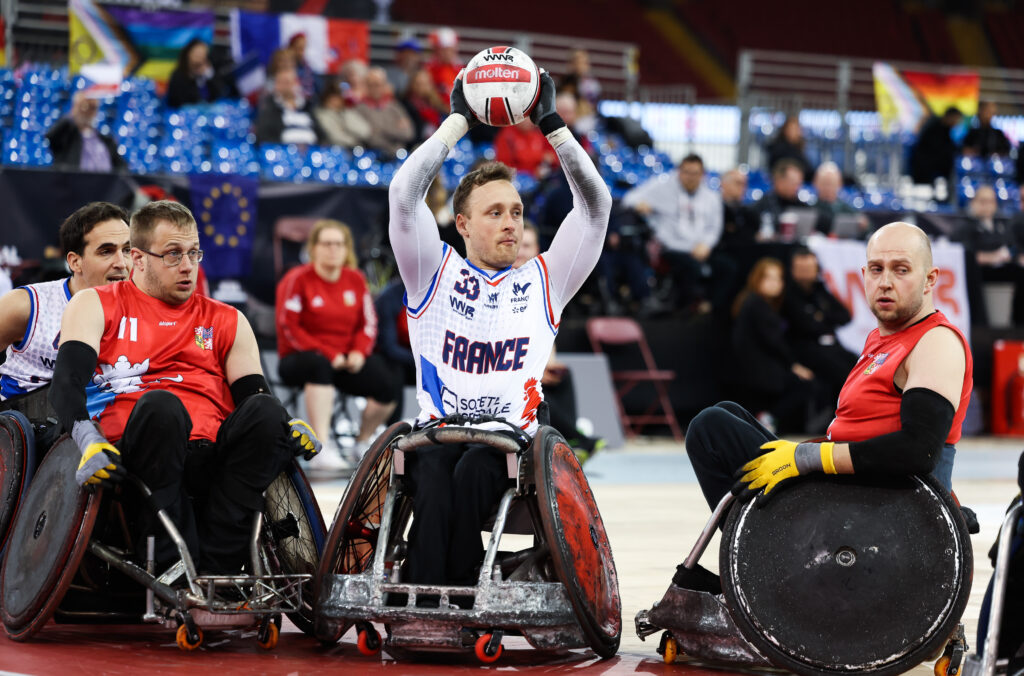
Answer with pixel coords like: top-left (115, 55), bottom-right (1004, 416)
top-left (195, 575), bottom-right (312, 615)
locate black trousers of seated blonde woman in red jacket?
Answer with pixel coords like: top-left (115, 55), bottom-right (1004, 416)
top-left (278, 352), bottom-right (401, 404)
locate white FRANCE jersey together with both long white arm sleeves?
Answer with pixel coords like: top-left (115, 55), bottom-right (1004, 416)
top-left (388, 115), bottom-right (611, 433)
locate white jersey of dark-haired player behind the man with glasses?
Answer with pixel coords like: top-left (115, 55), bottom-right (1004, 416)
top-left (0, 278), bottom-right (71, 399)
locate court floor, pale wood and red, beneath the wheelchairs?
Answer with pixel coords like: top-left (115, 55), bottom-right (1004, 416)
top-left (0, 437), bottom-right (1024, 676)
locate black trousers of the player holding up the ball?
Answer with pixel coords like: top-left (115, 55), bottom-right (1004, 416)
top-left (406, 443), bottom-right (509, 585)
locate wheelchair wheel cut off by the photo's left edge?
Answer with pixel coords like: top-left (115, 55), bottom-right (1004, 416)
top-left (0, 411), bottom-right (36, 557)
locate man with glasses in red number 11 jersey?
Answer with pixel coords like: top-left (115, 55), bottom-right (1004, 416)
top-left (50, 201), bottom-right (319, 575)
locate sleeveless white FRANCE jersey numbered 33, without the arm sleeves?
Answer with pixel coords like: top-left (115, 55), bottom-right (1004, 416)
top-left (407, 244), bottom-right (562, 432)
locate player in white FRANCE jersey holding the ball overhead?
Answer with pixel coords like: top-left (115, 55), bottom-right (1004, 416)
top-left (389, 74), bottom-right (611, 584)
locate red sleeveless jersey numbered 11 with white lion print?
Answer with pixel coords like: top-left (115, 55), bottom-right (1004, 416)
top-left (86, 281), bottom-right (239, 441)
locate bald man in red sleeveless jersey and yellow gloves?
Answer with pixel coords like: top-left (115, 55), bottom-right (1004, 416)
top-left (673, 222), bottom-right (973, 591)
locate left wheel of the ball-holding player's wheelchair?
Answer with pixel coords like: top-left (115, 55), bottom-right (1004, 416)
top-left (315, 422), bottom-right (411, 642)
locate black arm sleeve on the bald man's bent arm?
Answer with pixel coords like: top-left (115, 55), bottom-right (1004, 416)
top-left (850, 387), bottom-right (956, 474)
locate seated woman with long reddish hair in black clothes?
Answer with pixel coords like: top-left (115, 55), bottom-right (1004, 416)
top-left (732, 258), bottom-right (814, 432)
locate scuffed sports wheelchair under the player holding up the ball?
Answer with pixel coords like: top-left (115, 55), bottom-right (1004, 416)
top-left (314, 415), bottom-right (622, 663)
